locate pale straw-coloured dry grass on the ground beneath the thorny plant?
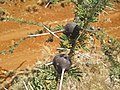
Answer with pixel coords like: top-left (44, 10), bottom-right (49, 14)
top-left (0, 47), bottom-right (120, 90)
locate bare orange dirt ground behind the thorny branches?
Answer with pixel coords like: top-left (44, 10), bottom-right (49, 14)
top-left (0, 0), bottom-right (120, 70)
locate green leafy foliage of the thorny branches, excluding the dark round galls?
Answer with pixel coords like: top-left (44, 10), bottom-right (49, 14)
top-left (0, 0), bottom-right (120, 90)
